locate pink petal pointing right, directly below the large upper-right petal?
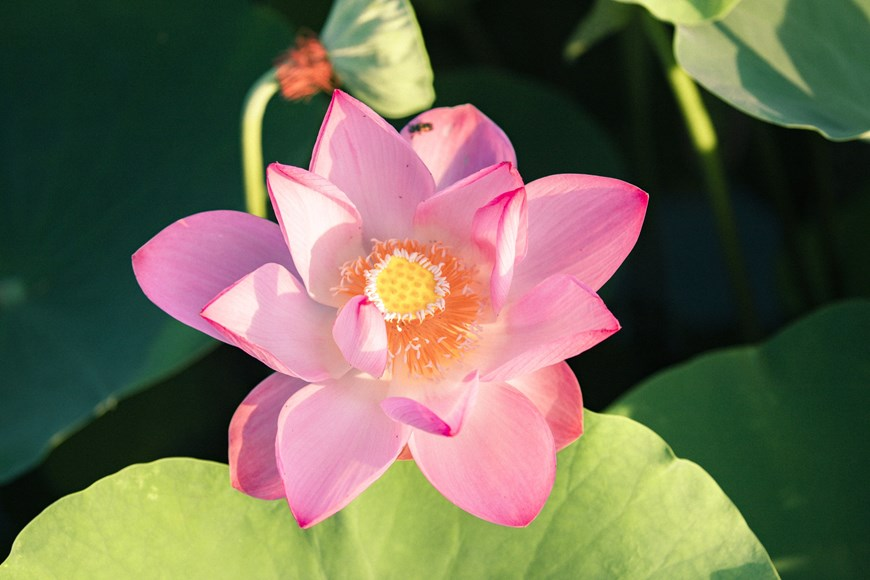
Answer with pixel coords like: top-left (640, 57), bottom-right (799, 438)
top-left (471, 274), bottom-right (619, 381)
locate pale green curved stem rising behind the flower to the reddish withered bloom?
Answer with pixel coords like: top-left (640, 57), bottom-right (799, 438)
top-left (242, 68), bottom-right (279, 217)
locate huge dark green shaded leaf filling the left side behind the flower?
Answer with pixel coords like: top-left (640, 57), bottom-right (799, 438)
top-left (0, 0), bottom-right (323, 481)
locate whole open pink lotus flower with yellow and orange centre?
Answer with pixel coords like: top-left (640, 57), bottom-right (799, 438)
top-left (133, 91), bottom-right (647, 527)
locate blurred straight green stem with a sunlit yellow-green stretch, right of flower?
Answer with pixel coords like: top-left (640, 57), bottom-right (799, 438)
top-left (643, 15), bottom-right (760, 340)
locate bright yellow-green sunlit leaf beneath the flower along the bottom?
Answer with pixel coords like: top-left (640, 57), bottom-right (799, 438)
top-left (0, 413), bottom-right (776, 579)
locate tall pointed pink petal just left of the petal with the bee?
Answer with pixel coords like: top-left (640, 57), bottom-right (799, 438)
top-left (310, 91), bottom-right (435, 240)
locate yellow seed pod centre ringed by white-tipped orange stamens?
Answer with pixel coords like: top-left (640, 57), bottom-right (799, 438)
top-left (335, 240), bottom-right (481, 378)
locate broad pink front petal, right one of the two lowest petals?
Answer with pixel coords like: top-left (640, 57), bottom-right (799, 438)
top-left (408, 383), bottom-right (556, 527)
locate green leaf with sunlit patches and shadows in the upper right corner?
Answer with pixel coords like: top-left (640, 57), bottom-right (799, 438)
top-left (675, 0), bottom-right (870, 140)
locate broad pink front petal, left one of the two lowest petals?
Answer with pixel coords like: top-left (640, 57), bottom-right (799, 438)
top-left (277, 375), bottom-right (410, 528)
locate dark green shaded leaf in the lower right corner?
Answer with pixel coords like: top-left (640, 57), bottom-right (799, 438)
top-left (610, 301), bottom-right (870, 579)
